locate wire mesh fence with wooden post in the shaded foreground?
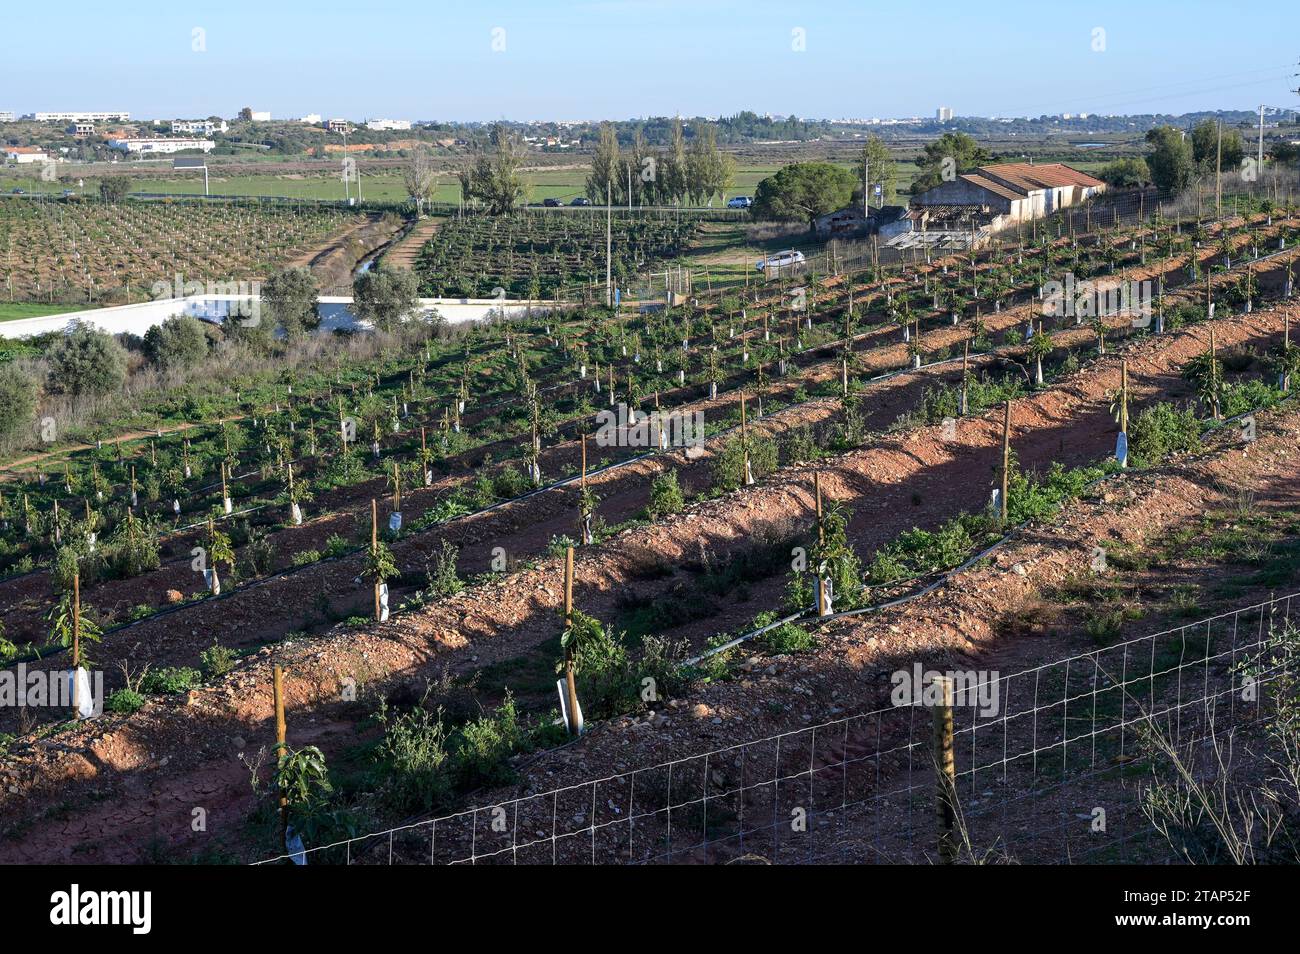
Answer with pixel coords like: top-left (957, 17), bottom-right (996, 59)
top-left (256, 594), bottom-right (1300, 864)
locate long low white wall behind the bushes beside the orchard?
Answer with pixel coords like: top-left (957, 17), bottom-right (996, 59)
top-left (0, 295), bottom-right (571, 338)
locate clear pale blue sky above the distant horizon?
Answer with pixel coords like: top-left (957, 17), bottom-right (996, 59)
top-left (0, 0), bottom-right (1300, 120)
